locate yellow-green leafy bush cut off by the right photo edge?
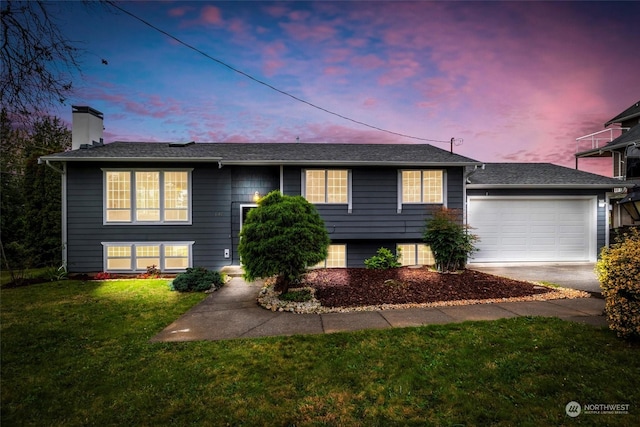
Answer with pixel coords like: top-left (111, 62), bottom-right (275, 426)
top-left (596, 229), bottom-right (640, 339)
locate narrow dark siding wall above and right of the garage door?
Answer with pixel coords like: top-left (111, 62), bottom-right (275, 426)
top-left (467, 189), bottom-right (609, 256)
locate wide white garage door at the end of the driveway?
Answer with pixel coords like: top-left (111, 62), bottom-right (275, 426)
top-left (467, 196), bottom-right (597, 263)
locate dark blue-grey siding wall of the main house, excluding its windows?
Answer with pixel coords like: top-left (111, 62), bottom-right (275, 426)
top-left (67, 162), bottom-right (464, 273)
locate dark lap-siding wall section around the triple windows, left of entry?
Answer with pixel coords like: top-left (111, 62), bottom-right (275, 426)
top-left (67, 163), bottom-right (231, 272)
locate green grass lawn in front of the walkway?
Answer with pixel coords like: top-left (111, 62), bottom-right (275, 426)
top-left (0, 280), bottom-right (640, 426)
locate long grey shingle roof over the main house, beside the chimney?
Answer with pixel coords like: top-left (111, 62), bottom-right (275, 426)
top-left (42, 142), bottom-right (480, 166)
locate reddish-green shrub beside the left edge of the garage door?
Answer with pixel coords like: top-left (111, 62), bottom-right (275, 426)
top-left (423, 208), bottom-right (478, 272)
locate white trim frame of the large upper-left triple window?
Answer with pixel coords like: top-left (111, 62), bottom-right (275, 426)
top-left (102, 168), bottom-right (193, 225)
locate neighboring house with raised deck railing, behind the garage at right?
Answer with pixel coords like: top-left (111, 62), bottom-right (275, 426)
top-left (575, 101), bottom-right (640, 228)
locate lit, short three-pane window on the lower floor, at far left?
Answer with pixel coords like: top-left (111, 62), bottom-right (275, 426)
top-left (102, 242), bottom-right (193, 272)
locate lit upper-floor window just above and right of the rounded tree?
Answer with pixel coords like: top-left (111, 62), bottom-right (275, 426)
top-left (303, 169), bottom-right (350, 204)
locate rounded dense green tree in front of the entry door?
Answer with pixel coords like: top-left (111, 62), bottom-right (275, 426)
top-left (238, 191), bottom-right (330, 293)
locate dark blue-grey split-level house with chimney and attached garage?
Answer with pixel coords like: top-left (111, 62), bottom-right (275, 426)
top-left (41, 107), bottom-right (632, 273)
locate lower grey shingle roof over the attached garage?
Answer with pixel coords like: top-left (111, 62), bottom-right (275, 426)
top-left (467, 163), bottom-right (629, 189)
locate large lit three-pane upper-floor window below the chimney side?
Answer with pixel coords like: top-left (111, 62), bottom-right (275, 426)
top-left (104, 170), bottom-right (191, 224)
